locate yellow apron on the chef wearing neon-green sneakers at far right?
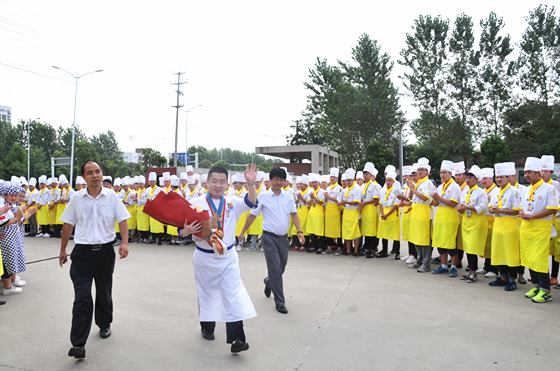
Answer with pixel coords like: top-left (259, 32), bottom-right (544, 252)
top-left (519, 219), bottom-right (551, 273)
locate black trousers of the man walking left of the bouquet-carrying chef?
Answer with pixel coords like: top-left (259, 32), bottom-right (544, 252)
top-left (70, 246), bottom-right (115, 346)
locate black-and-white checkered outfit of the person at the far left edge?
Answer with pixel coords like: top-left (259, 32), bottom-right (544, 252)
top-left (0, 204), bottom-right (26, 275)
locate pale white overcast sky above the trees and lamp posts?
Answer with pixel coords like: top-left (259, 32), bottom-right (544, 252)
top-left (0, 0), bottom-right (558, 160)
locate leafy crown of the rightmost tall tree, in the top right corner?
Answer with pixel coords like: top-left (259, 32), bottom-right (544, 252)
top-left (517, 5), bottom-right (560, 105)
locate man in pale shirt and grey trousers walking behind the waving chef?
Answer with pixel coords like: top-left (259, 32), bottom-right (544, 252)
top-left (239, 167), bottom-right (305, 314)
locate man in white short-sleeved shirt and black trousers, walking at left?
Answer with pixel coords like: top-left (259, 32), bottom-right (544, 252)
top-left (58, 160), bottom-right (130, 358)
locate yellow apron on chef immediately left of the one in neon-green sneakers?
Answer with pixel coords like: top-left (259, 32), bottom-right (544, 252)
top-left (490, 216), bottom-right (521, 267)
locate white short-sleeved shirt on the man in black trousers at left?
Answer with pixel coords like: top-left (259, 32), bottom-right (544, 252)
top-left (60, 187), bottom-right (130, 245)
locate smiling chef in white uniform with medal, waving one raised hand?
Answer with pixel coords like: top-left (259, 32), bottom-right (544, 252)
top-left (179, 165), bottom-right (257, 353)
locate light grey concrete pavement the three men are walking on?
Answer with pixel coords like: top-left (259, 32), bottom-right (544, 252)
top-left (0, 238), bottom-right (560, 371)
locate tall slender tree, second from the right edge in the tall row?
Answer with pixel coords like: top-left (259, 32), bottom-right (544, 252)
top-left (477, 12), bottom-right (515, 136)
